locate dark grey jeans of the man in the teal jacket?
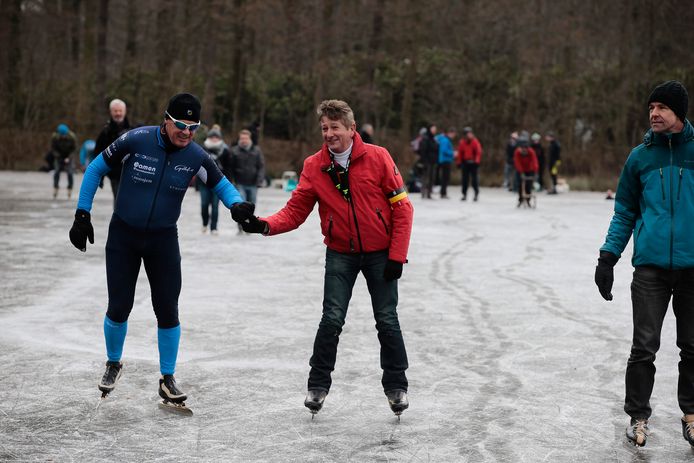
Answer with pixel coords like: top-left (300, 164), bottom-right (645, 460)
top-left (624, 266), bottom-right (694, 418)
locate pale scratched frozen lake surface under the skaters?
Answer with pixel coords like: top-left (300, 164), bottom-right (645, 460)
top-left (0, 172), bottom-right (694, 462)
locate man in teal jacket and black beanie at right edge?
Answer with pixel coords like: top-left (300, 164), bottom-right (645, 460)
top-left (595, 81), bottom-right (694, 446)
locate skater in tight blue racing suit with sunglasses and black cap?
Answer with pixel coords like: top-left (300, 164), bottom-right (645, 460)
top-left (70, 93), bottom-right (254, 404)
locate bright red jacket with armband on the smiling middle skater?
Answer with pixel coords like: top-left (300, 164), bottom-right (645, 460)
top-left (261, 133), bottom-right (414, 263)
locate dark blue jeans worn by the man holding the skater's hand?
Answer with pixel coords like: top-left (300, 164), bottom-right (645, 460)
top-left (308, 249), bottom-right (408, 391)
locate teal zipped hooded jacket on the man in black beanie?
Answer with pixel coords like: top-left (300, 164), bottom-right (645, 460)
top-left (600, 120), bottom-right (694, 269)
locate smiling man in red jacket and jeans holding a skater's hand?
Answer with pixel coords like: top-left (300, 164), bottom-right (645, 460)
top-left (237, 100), bottom-right (413, 415)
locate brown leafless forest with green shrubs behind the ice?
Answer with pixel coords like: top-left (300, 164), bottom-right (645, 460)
top-left (0, 0), bottom-right (694, 189)
